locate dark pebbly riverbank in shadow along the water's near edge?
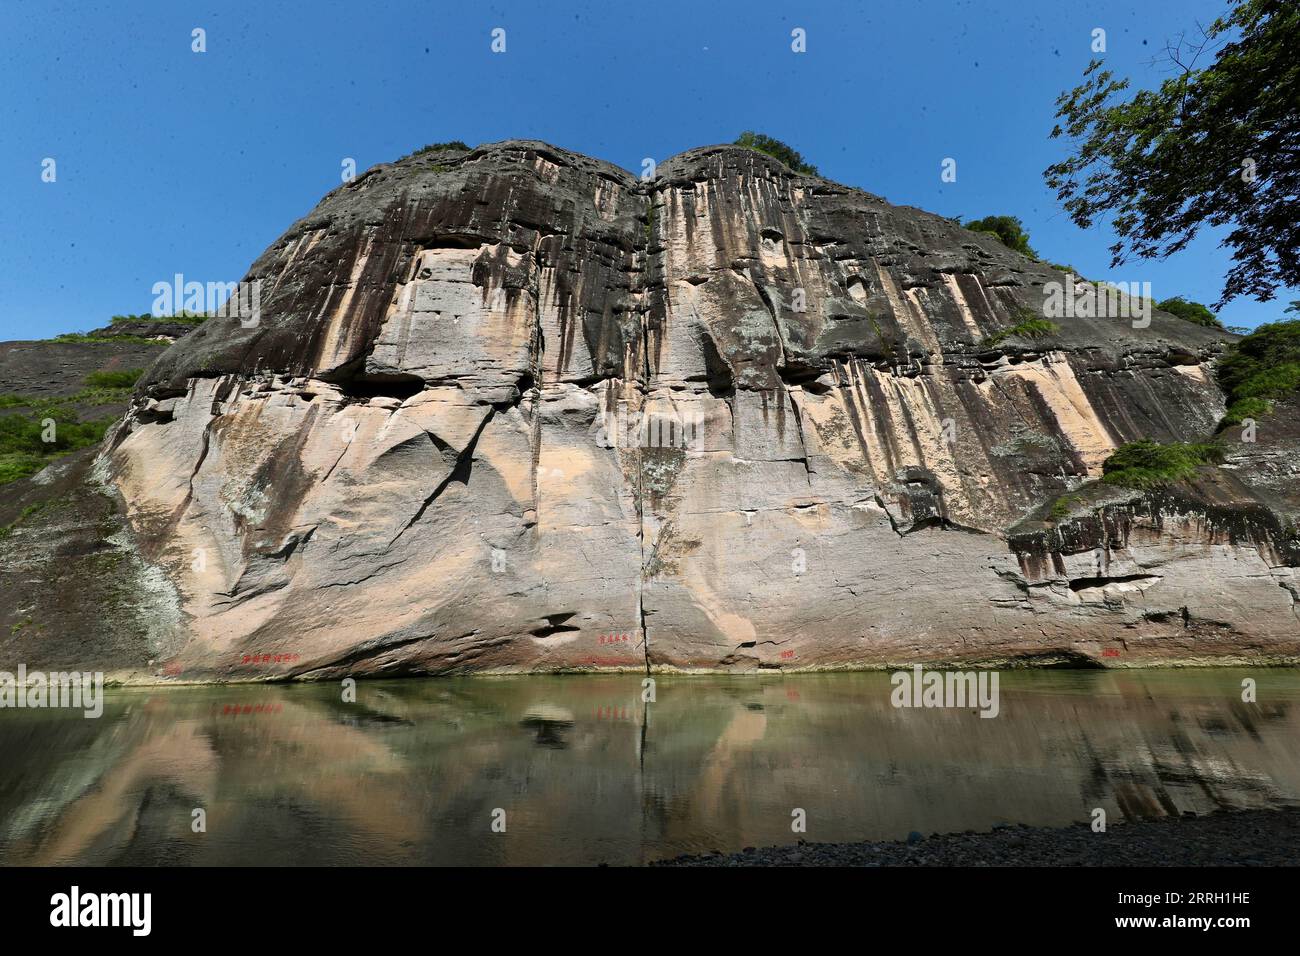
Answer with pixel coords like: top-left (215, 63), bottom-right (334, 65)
top-left (651, 808), bottom-right (1300, 866)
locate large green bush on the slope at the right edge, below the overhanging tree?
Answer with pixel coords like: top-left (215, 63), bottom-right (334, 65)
top-left (1216, 319), bottom-right (1300, 427)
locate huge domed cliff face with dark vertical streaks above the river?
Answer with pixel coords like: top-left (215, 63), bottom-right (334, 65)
top-left (35, 140), bottom-right (1300, 680)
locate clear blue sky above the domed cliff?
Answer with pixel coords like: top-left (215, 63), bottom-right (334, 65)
top-left (0, 0), bottom-right (1300, 339)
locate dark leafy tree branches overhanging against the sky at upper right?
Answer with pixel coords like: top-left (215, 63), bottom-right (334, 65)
top-left (1044, 0), bottom-right (1300, 306)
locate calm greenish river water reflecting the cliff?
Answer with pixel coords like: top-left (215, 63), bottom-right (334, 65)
top-left (0, 670), bottom-right (1300, 865)
